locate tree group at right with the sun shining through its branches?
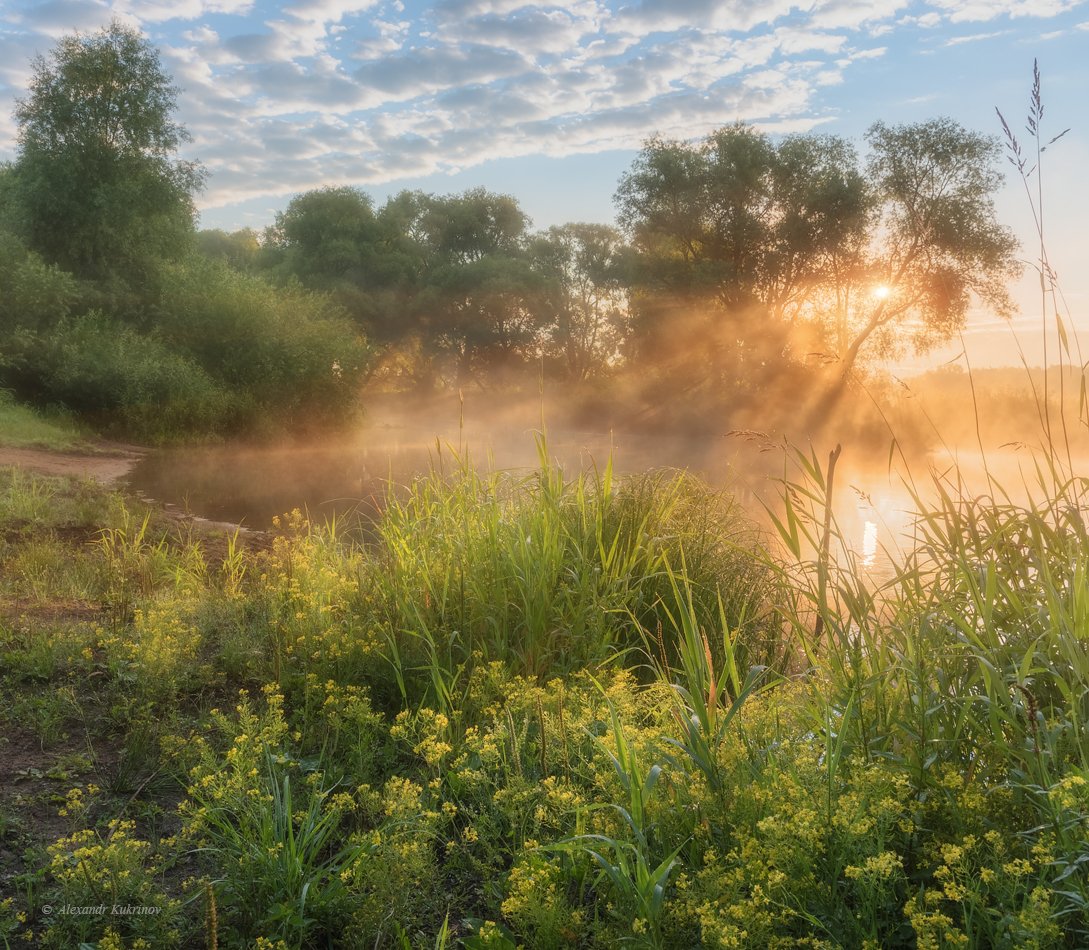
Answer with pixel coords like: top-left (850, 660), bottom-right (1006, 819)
top-left (616, 119), bottom-right (1017, 382)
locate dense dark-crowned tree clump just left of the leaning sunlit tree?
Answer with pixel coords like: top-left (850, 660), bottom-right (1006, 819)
top-left (616, 124), bottom-right (869, 381)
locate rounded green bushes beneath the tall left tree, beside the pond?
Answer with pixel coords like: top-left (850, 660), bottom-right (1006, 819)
top-left (0, 240), bottom-right (369, 442)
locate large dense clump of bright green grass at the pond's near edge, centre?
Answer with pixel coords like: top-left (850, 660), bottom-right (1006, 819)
top-left (367, 438), bottom-right (781, 702)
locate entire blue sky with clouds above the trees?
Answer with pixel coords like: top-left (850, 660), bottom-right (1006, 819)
top-left (0, 0), bottom-right (1089, 363)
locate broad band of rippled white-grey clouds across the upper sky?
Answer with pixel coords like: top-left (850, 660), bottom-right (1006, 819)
top-left (0, 0), bottom-right (1089, 237)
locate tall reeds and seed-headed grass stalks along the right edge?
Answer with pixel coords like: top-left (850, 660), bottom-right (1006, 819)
top-left (753, 63), bottom-right (1089, 946)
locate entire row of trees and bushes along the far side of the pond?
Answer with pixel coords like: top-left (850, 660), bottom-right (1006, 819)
top-left (0, 23), bottom-right (1018, 442)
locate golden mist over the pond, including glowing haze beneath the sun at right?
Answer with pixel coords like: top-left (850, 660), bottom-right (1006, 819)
top-left (129, 374), bottom-right (1089, 601)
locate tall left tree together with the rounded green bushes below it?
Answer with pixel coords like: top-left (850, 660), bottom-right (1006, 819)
top-left (0, 22), bottom-right (369, 442)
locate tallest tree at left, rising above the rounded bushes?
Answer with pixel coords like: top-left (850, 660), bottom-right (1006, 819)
top-left (15, 21), bottom-right (204, 283)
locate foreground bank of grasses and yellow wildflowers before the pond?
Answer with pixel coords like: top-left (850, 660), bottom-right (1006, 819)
top-left (0, 433), bottom-right (1089, 948)
